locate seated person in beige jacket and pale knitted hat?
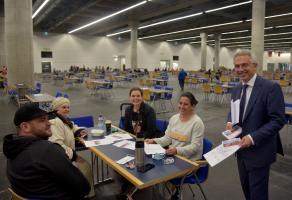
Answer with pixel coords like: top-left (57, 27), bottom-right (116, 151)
top-left (49, 97), bottom-right (95, 197)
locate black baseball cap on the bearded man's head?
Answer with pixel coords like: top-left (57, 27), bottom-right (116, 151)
top-left (14, 103), bottom-right (52, 126)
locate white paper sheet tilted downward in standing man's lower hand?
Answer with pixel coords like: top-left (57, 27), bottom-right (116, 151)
top-left (203, 144), bottom-right (240, 167)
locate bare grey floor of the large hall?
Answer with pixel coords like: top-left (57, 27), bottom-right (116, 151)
top-left (0, 77), bottom-right (292, 200)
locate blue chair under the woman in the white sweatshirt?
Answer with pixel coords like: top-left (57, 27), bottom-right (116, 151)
top-left (170, 138), bottom-right (213, 200)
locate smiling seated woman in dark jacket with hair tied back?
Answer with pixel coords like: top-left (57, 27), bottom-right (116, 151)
top-left (125, 87), bottom-right (161, 138)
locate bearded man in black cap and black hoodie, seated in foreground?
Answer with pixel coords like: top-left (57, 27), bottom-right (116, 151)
top-left (3, 104), bottom-right (90, 200)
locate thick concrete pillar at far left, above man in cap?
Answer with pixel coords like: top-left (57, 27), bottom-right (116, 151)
top-left (4, 0), bottom-right (33, 86)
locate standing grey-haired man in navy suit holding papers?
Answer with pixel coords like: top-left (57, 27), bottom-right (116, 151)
top-left (226, 51), bottom-right (285, 200)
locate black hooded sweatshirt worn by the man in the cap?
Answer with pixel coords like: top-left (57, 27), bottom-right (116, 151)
top-left (3, 134), bottom-right (90, 200)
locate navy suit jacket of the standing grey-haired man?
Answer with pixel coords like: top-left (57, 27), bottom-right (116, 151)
top-left (231, 76), bottom-right (285, 167)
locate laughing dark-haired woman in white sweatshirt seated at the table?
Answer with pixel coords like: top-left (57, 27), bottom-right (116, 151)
top-left (145, 92), bottom-right (205, 161)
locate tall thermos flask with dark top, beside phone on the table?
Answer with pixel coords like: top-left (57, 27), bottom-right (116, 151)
top-left (135, 133), bottom-right (144, 172)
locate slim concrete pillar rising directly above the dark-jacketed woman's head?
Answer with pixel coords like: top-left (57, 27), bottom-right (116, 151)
top-left (130, 22), bottom-right (138, 69)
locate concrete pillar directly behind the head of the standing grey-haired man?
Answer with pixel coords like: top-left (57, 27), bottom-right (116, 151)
top-left (251, 0), bottom-right (266, 74)
